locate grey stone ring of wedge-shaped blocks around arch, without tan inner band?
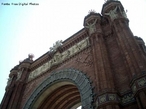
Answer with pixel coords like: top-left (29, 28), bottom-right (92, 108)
top-left (23, 69), bottom-right (94, 109)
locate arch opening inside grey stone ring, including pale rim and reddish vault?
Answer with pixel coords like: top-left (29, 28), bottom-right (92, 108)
top-left (32, 81), bottom-right (81, 109)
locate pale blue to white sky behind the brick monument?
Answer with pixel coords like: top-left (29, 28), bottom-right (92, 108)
top-left (0, 0), bottom-right (146, 107)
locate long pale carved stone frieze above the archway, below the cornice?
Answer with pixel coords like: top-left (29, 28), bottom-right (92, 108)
top-left (28, 38), bottom-right (89, 81)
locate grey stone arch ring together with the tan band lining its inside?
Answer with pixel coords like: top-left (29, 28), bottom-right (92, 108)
top-left (23, 69), bottom-right (94, 109)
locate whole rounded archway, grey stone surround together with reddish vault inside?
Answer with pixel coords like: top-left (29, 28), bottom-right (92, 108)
top-left (23, 69), bottom-right (94, 109)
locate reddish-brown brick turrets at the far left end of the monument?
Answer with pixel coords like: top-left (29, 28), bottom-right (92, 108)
top-left (1, 55), bottom-right (33, 109)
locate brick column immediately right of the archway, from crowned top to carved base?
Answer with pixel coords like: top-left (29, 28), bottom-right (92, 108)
top-left (84, 12), bottom-right (118, 109)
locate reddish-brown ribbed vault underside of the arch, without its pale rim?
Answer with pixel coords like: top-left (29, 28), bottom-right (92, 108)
top-left (38, 84), bottom-right (81, 109)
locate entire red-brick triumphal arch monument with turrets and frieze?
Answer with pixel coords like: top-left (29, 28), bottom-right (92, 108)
top-left (1, 0), bottom-right (146, 109)
